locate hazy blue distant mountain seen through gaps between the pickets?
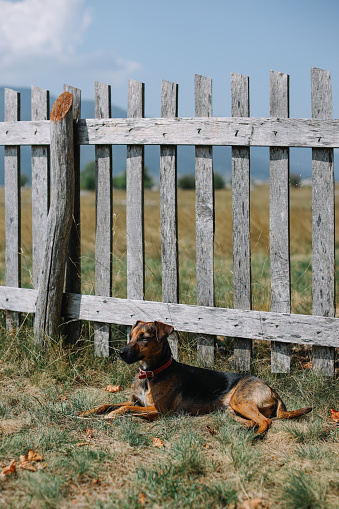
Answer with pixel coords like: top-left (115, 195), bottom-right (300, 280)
top-left (0, 87), bottom-right (318, 186)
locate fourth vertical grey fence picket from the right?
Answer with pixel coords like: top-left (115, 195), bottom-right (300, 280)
top-left (195, 75), bottom-right (215, 366)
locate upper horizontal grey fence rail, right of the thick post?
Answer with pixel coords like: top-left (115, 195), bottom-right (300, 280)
top-left (74, 117), bottom-right (339, 148)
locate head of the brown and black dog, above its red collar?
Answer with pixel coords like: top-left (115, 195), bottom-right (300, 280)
top-left (119, 320), bottom-right (174, 364)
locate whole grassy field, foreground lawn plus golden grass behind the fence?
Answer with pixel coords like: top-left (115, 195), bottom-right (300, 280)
top-left (0, 186), bottom-right (339, 509)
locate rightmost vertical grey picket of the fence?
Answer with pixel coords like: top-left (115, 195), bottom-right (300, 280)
top-left (311, 68), bottom-right (335, 376)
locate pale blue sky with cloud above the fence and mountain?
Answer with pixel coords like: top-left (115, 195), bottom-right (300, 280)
top-left (0, 0), bottom-right (339, 118)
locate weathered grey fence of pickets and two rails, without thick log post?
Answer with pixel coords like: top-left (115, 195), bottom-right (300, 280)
top-left (0, 68), bottom-right (339, 376)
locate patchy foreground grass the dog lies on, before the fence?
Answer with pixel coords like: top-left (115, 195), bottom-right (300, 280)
top-left (0, 326), bottom-right (339, 509)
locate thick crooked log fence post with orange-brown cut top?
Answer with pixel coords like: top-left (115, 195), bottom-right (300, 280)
top-left (34, 92), bottom-right (74, 345)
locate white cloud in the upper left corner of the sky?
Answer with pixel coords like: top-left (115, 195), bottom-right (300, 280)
top-left (0, 0), bottom-right (140, 95)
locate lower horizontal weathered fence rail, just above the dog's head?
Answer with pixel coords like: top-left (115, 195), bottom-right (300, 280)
top-left (0, 286), bottom-right (339, 347)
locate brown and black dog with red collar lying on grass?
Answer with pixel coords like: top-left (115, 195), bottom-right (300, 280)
top-left (80, 321), bottom-right (312, 433)
